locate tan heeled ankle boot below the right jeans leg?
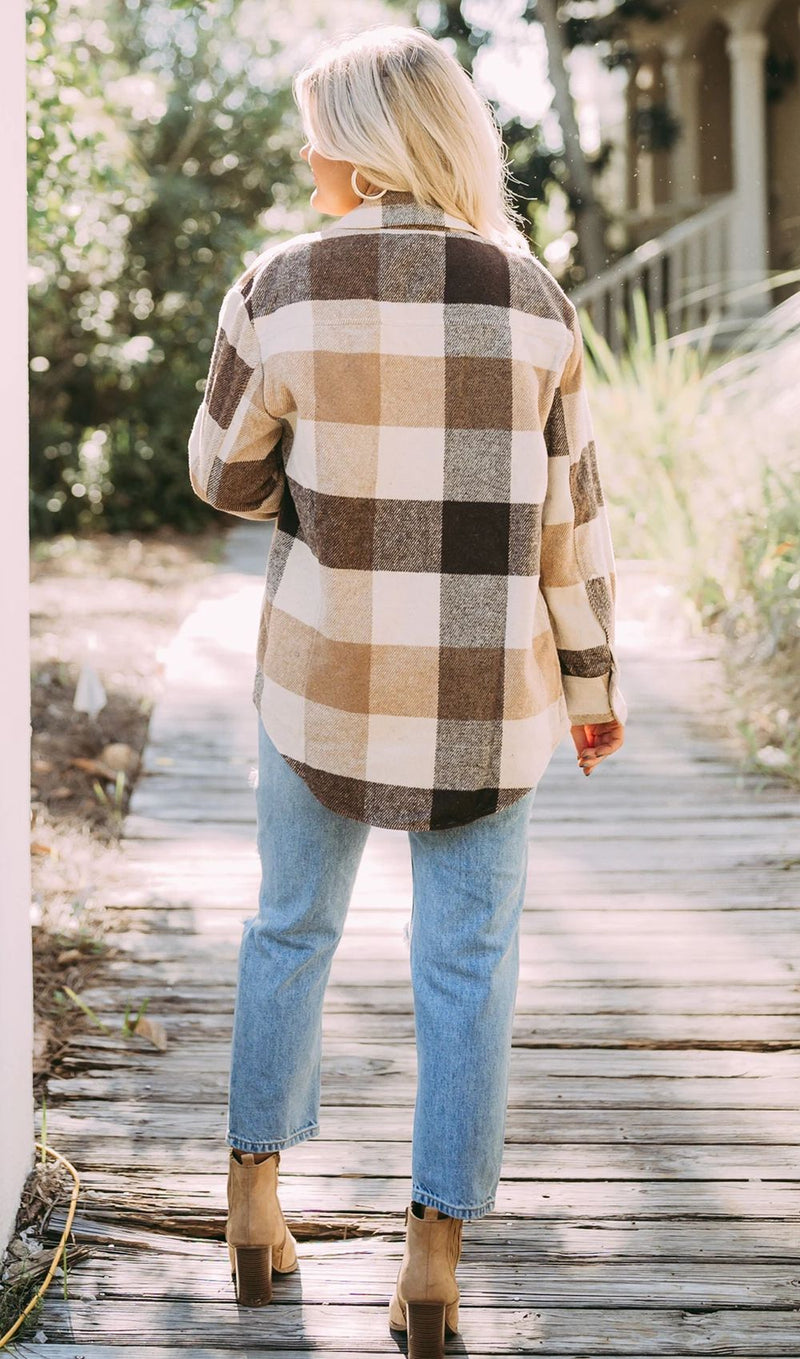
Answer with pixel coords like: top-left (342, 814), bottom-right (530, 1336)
top-left (388, 1205), bottom-right (462, 1359)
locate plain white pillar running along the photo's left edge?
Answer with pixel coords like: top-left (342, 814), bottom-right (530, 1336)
top-left (0, 0), bottom-right (34, 1250)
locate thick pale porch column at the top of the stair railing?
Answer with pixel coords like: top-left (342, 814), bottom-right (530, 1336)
top-left (728, 29), bottom-right (770, 315)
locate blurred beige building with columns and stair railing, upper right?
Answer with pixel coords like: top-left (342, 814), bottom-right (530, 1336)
top-left (575, 0), bottom-right (800, 338)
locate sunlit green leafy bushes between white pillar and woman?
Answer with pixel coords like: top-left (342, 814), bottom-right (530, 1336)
top-left (29, 0), bottom-right (303, 535)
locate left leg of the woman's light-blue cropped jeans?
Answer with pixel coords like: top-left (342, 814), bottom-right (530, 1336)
top-left (225, 715), bottom-right (369, 1151)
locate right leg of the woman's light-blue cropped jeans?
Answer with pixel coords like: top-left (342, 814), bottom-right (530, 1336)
top-left (409, 788), bottom-right (535, 1219)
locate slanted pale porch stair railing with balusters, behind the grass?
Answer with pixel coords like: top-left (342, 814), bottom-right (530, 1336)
top-left (569, 194), bottom-right (735, 352)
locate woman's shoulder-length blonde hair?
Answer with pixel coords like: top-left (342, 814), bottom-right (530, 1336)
top-left (292, 24), bottom-right (531, 255)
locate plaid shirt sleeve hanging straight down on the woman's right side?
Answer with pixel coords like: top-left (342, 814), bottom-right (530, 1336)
top-left (539, 307), bottom-right (628, 726)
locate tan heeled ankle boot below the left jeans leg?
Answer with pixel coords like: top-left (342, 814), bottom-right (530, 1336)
top-left (225, 1147), bottom-right (297, 1307)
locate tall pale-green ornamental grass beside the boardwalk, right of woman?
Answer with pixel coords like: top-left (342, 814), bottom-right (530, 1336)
top-left (581, 294), bottom-right (800, 783)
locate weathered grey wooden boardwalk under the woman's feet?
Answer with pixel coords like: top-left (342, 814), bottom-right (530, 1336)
top-left (23, 523), bottom-right (800, 1359)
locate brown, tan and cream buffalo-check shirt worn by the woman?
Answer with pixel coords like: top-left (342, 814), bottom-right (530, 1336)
top-left (189, 192), bottom-right (628, 830)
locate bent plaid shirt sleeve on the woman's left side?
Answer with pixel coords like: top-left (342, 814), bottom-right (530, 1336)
top-left (189, 285), bottom-right (285, 519)
